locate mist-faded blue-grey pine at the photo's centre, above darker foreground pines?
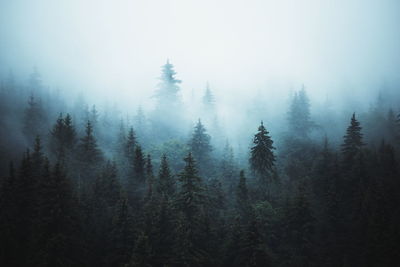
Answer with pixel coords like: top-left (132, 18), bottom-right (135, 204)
top-left (189, 119), bottom-right (212, 177)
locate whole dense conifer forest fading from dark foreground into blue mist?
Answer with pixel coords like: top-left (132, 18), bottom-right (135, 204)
top-left (0, 62), bottom-right (400, 267)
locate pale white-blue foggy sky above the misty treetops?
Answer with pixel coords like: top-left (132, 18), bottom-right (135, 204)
top-left (0, 0), bottom-right (400, 110)
